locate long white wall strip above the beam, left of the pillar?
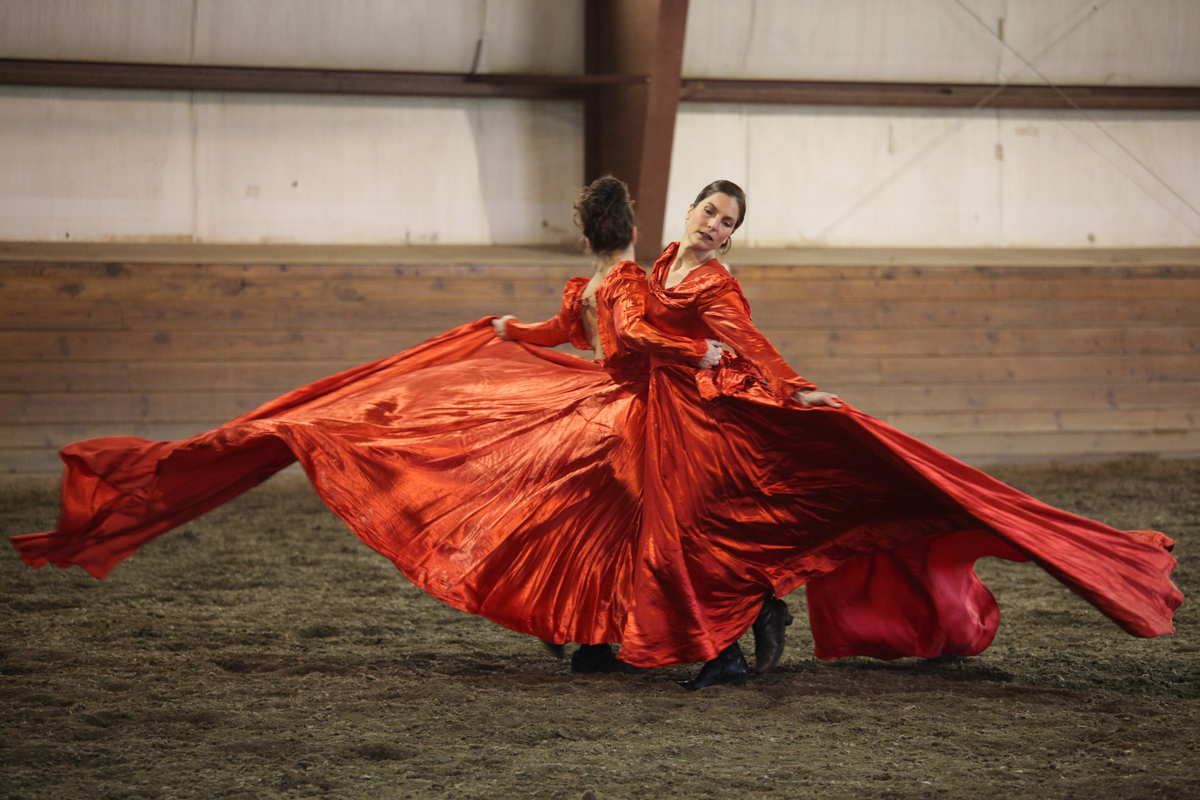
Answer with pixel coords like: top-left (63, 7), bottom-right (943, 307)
top-left (0, 0), bottom-right (583, 73)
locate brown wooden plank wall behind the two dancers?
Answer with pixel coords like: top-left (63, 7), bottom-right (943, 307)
top-left (0, 245), bottom-right (1200, 475)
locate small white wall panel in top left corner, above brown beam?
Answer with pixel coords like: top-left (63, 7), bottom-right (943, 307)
top-left (0, 0), bottom-right (193, 62)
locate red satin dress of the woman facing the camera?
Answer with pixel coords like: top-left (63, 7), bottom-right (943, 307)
top-left (622, 245), bottom-right (1183, 663)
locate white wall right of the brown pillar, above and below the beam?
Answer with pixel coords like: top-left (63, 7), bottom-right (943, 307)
top-left (665, 0), bottom-right (1200, 247)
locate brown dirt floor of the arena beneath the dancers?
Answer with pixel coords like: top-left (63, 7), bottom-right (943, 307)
top-left (0, 458), bottom-right (1200, 800)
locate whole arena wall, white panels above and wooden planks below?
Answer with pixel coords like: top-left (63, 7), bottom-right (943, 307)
top-left (0, 0), bottom-right (1200, 474)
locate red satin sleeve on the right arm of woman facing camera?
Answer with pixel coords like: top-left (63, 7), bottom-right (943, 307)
top-left (698, 276), bottom-right (816, 399)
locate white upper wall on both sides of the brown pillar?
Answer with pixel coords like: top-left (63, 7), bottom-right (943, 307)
top-left (0, 0), bottom-right (1200, 247)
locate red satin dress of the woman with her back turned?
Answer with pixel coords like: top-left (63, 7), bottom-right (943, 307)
top-left (12, 263), bottom-right (686, 664)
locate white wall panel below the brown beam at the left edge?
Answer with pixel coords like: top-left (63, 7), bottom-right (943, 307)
top-left (0, 88), bottom-right (193, 241)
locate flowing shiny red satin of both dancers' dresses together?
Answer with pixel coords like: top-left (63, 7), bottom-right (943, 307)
top-left (13, 249), bottom-right (1181, 667)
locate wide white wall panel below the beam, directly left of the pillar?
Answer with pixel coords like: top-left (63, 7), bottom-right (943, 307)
top-left (197, 95), bottom-right (583, 243)
